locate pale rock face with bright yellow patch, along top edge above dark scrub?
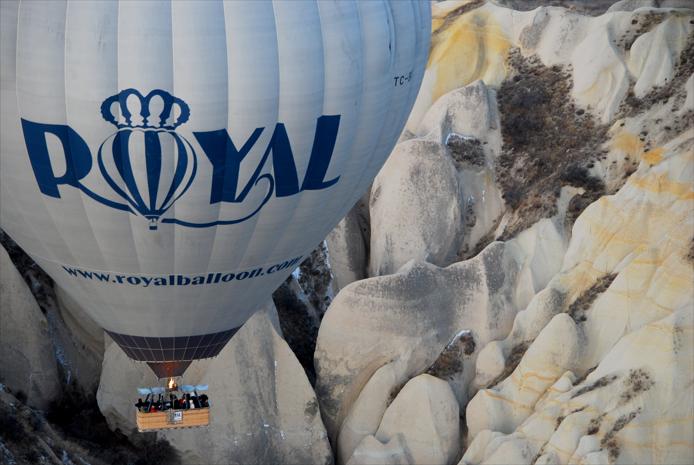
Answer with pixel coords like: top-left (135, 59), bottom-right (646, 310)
top-left (407, 1), bottom-right (694, 131)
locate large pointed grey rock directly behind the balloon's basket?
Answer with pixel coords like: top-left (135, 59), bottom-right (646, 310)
top-left (97, 307), bottom-right (333, 465)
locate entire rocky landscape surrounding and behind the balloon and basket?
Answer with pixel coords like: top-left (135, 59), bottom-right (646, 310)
top-left (0, 0), bottom-right (694, 465)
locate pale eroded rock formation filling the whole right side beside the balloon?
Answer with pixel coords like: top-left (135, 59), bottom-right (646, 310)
top-left (315, 1), bottom-right (694, 464)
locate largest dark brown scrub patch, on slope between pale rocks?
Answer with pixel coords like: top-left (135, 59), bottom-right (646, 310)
top-left (495, 50), bottom-right (608, 240)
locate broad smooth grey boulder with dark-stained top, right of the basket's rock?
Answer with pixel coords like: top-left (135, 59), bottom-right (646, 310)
top-left (315, 220), bottom-right (564, 442)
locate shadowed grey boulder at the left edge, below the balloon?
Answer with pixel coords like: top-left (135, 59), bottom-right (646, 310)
top-left (0, 246), bottom-right (61, 408)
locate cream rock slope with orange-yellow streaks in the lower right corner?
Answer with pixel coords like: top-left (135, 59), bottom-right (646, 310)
top-left (463, 86), bottom-right (694, 463)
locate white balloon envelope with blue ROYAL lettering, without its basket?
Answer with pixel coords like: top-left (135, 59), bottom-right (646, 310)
top-left (0, 0), bottom-right (431, 392)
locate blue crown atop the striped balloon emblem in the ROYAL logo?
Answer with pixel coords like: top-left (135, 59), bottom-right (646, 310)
top-left (101, 89), bottom-right (190, 130)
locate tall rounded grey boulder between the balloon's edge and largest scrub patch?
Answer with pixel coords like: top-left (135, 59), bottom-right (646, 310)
top-left (369, 81), bottom-right (504, 276)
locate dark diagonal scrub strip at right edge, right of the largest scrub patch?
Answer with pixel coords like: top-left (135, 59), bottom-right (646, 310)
top-left (618, 33), bottom-right (694, 123)
